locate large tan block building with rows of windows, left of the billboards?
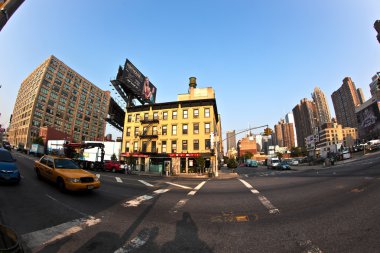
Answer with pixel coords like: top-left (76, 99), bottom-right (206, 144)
top-left (8, 55), bottom-right (110, 148)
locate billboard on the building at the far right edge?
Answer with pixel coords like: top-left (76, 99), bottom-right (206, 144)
top-left (356, 101), bottom-right (380, 140)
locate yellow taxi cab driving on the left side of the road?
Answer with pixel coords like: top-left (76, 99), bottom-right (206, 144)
top-left (34, 155), bottom-right (100, 191)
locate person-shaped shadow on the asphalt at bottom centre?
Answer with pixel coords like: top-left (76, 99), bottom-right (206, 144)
top-left (161, 212), bottom-right (212, 253)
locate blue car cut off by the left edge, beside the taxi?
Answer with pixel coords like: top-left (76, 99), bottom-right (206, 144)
top-left (0, 148), bottom-right (21, 184)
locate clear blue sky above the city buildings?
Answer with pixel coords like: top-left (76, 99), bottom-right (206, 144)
top-left (0, 0), bottom-right (380, 141)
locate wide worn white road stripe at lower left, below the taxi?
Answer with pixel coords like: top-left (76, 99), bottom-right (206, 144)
top-left (21, 216), bottom-right (101, 249)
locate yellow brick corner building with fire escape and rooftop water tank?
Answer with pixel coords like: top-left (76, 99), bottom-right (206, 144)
top-left (122, 77), bottom-right (223, 175)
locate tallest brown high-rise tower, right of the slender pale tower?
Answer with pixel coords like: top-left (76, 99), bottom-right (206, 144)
top-left (331, 77), bottom-right (360, 128)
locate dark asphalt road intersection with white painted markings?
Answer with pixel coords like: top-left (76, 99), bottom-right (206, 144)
top-left (0, 153), bottom-right (380, 253)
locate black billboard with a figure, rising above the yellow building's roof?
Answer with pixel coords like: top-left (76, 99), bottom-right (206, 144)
top-left (121, 59), bottom-right (157, 104)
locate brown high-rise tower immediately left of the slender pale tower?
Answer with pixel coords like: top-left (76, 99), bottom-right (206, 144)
top-left (292, 98), bottom-right (318, 147)
